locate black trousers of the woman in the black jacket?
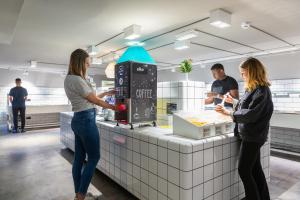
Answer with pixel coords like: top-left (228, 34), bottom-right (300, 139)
top-left (238, 141), bottom-right (270, 200)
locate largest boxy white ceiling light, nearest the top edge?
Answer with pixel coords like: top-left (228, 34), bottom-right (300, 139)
top-left (209, 9), bottom-right (231, 28)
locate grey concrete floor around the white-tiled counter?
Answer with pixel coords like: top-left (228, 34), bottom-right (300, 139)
top-left (0, 129), bottom-right (300, 200)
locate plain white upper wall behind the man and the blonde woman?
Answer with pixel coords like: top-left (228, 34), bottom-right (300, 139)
top-left (158, 52), bottom-right (300, 83)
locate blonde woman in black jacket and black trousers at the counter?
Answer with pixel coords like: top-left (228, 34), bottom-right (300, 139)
top-left (216, 58), bottom-right (273, 200)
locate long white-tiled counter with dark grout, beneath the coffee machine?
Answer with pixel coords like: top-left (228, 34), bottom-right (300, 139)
top-left (61, 113), bottom-right (270, 200)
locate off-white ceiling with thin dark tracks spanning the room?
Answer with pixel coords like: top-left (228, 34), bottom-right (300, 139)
top-left (0, 0), bottom-right (300, 74)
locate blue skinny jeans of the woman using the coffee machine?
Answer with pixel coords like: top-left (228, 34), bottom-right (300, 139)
top-left (71, 109), bottom-right (100, 195)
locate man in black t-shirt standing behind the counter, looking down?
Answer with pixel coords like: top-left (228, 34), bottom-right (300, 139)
top-left (205, 63), bottom-right (239, 107)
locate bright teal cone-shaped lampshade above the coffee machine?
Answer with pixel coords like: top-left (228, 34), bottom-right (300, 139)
top-left (117, 46), bottom-right (156, 65)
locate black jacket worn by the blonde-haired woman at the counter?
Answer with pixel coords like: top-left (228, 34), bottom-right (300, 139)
top-left (233, 87), bottom-right (273, 143)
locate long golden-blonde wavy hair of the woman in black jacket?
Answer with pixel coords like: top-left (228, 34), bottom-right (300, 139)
top-left (240, 57), bottom-right (271, 91)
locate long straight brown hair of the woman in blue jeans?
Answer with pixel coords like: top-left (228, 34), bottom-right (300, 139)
top-left (68, 49), bottom-right (89, 79)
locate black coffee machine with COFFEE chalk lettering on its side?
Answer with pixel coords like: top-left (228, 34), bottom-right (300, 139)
top-left (115, 61), bottom-right (157, 128)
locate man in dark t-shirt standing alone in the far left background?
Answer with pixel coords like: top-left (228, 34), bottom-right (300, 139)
top-left (9, 78), bottom-right (28, 133)
